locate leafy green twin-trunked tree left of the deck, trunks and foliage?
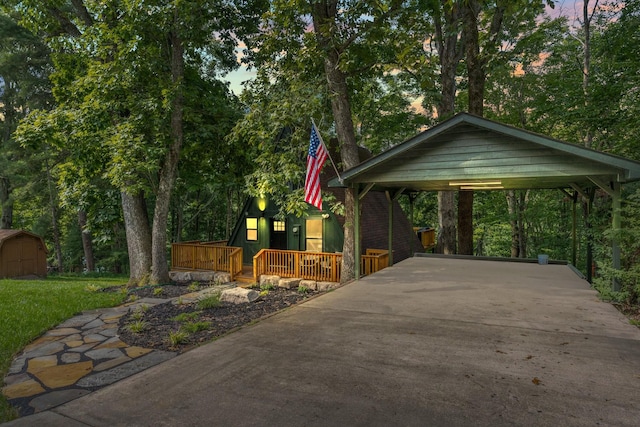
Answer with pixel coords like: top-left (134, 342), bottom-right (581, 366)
top-left (6, 0), bottom-right (253, 283)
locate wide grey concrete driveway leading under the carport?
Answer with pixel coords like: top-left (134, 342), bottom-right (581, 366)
top-left (7, 258), bottom-right (640, 426)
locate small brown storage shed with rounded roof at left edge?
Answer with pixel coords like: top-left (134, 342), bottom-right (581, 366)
top-left (0, 230), bottom-right (47, 279)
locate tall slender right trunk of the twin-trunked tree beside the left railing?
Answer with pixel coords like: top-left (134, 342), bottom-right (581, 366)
top-left (150, 21), bottom-right (184, 284)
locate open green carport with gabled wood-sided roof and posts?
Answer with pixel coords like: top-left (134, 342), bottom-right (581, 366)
top-left (329, 113), bottom-right (640, 286)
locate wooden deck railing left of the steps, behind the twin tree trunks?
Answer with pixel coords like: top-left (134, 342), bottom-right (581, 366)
top-left (171, 241), bottom-right (242, 280)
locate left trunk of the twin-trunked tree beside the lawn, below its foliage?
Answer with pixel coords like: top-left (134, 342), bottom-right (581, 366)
top-left (120, 191), bottom-right (151, 287)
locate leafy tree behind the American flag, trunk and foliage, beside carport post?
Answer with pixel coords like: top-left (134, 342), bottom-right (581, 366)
top-left (240, 0), bottom-right (416, 280)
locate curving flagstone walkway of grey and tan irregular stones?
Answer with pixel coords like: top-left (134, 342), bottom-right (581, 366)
top-left (2, 288), bottom-right (228, 416)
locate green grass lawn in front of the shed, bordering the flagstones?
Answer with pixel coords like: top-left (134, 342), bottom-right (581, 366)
top-left (0, 276), bottom-right (128, 423)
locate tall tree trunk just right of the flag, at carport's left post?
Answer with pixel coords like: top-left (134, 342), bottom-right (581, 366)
top-left (312, 0), bottom-right (360, 282)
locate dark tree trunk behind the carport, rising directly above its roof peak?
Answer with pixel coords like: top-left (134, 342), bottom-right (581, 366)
top-left (434, 0), bottom-right (463, 254)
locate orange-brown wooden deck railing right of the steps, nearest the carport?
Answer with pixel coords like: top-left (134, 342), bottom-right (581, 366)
top-left (253, 249), bottom-right (389, 282)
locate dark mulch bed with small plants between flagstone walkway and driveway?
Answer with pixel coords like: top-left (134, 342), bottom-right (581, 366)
top-left (118, 285), bottom-right (319, 352)
